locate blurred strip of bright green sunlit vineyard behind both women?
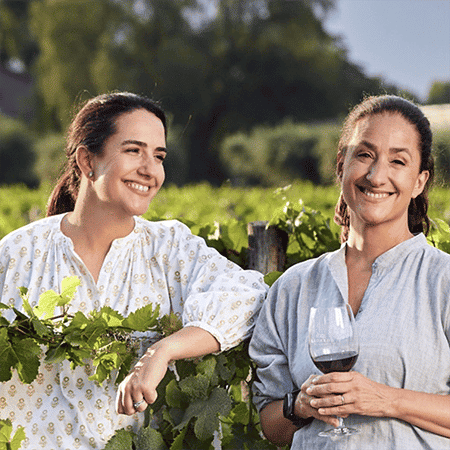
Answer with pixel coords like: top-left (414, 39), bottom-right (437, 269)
top-left (0, 181), bottom-right (450, 241)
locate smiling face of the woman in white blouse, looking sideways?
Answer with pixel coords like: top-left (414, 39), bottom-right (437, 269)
top-left (92, 109), bottom-right (166, 218)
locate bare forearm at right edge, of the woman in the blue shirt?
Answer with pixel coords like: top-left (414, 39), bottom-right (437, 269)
top-left (389, 389), bottom-right (450, 437)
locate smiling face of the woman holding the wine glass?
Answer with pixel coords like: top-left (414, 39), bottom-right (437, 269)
top-left (338, 113), bottom-right (429, 233)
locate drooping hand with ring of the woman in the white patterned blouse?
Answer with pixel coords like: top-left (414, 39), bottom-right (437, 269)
top-left (116, 347), bottom-right (170, 415)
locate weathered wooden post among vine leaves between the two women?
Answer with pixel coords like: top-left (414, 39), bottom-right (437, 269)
top-left (247, 221), bottom-right (289, 275)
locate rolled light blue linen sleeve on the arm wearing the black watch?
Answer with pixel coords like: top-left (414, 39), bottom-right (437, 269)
top-left (249, 277), bottom-right (294, 411)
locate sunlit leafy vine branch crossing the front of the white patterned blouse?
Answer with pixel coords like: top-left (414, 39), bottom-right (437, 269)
top-left (0, 277), bottom-right (160, 384)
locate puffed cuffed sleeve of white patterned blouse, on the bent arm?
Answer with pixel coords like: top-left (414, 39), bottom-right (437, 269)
top-left (168, 221), bottom-right (268, 351)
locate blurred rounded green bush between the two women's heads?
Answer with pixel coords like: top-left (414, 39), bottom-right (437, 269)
top-left (220, 120), bottom-right (340, 186)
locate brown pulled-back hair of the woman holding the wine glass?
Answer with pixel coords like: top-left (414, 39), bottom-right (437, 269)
top-left (334, 95), bottom-right (434, 242)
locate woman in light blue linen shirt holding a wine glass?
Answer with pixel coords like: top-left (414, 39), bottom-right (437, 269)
top-left (250, 95), bottom-right (450, 450)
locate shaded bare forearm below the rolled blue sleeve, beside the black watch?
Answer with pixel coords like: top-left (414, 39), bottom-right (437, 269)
top-left (260, 400), bottom-right (298, 446)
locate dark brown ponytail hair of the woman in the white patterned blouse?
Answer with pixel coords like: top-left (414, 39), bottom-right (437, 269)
top-left (47, 92), bottom-right (167, 216)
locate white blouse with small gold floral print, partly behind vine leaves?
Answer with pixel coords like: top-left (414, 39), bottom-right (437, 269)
top-left (0, 215), bottom-right (267, 450)
